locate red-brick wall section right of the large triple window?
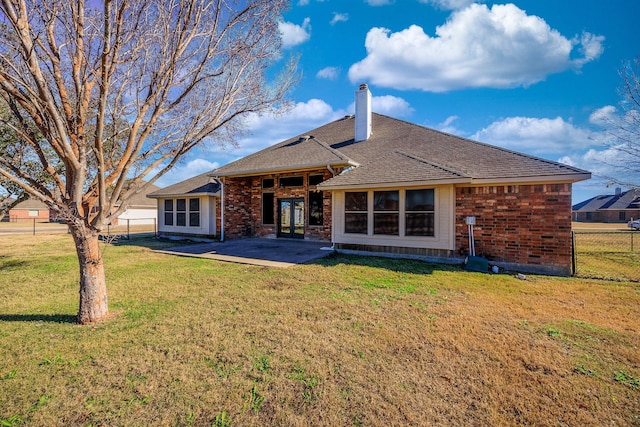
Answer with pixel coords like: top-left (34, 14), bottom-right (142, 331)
top-left (456, 184), bottom-right (572, 275)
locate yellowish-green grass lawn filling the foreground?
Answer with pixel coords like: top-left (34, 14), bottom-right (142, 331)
top-left (0, 235), bottom-right (640, 426)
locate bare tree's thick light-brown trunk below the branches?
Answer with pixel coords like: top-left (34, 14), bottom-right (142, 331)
top-left (69, 223), bottom-right (109, 325)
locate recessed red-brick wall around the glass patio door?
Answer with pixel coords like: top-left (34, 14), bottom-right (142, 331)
top-left (217, 169), bottom-right (332, 241)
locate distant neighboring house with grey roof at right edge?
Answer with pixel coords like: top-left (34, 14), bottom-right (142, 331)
top-left (573, 188), bottom-right (640, 223)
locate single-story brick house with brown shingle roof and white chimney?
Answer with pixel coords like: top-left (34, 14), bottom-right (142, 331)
top-left (150, 85), bottom-right (591, 275)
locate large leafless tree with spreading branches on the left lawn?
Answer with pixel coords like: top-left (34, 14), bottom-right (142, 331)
top-left (0, 0), bottom-right (295, 324)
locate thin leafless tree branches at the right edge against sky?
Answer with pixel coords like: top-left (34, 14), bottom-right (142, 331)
top-left (597, 56), bottom-right (640, 188)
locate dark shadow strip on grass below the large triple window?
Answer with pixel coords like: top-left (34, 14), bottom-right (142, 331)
top-left (306, 253), bottom-right (465, 274)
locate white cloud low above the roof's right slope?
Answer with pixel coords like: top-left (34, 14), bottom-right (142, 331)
top-left (471, 117), bottom-right (602, 155)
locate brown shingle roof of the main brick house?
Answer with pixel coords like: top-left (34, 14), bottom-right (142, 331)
top-left (164, 113), bottom-right (591, 194)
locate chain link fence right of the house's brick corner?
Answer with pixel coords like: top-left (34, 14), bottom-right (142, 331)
top-left (573, 231), bottom-right (640, 281)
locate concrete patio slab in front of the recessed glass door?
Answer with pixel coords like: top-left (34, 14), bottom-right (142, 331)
top-left (156, 238), bottom-right (333, 267)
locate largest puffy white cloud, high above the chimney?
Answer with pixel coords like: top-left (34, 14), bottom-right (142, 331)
top-left (349, 4), bottom-right (604, 92)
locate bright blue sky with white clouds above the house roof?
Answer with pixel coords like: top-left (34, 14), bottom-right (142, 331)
top-left (158, 0), bottom-right (640, 203)
